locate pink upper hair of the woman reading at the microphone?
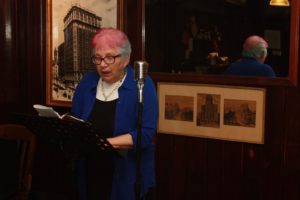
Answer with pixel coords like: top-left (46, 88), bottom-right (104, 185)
top-left (91, 28), bottom-right (131, 55)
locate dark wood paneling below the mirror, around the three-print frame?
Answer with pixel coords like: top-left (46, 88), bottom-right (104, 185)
top-left (151, 73), bottom-right (300, 200)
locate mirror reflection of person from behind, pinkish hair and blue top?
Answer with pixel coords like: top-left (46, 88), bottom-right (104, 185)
top-left (224, 35), bottom-right (276, 77)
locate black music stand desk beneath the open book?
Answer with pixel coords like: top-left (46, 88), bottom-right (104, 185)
top-left (15, 113), bottom-right (120, 159)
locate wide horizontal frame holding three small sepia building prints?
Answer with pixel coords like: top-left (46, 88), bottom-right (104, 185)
top-left (157, 82), bottom-right (265, 144)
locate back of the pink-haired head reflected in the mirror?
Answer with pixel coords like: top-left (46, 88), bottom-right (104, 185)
top-left (242, 35), bottom-right (268, 63)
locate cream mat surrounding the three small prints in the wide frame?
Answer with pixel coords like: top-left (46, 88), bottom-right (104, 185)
top-left (158, 82), bottom-right (265, 144)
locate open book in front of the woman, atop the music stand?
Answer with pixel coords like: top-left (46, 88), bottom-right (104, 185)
top-left (33, 104), bottom-right (84, 122)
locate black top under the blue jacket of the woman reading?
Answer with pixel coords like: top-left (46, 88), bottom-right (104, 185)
top-left (86, 99), bottom-right (118, 200)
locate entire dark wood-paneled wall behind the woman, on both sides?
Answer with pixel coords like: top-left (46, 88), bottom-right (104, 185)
top-left (0, 0), bottom-right (300, 200)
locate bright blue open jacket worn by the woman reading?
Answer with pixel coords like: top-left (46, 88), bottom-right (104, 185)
top-left (72, 66), bottom-right (158, 200)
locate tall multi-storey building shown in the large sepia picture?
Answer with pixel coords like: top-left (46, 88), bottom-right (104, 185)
top-left (60, 3), bottom-right (102, 84)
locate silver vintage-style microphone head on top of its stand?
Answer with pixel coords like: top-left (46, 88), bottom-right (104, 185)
top-left (134, 61), bottom-right (149, 103)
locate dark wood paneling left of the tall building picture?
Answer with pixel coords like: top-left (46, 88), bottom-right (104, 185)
top-left (0, 0), bottom-right (45, 122)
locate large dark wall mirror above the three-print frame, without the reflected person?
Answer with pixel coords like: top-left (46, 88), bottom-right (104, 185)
top-left (145, 0), bottom-right (299, 83)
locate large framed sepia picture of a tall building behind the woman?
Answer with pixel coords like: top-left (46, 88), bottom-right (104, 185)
top-left (46, 0), bottom-right (124, 106)
